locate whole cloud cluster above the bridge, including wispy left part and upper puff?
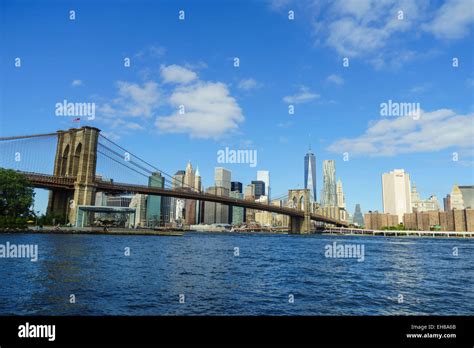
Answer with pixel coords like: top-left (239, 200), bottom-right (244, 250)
top-left (99, 64), bottom-right (245, 139)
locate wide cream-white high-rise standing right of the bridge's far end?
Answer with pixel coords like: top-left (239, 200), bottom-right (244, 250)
top-left (382, 169), bottom-right (412, 223)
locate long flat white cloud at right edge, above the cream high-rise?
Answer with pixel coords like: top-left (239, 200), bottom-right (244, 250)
top-left (327, 109), bottom-right (474, 157)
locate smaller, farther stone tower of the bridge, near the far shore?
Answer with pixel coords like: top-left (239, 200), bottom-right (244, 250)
top-left (288, 189), bottom-right (311, 234)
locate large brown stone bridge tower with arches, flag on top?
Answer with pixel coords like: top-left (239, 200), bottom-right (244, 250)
top-left (48, 127), bottom-right (100, 225)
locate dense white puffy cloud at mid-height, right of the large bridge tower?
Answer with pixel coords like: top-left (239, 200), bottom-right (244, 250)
top-left (155, 81), bottom-right (244, 139)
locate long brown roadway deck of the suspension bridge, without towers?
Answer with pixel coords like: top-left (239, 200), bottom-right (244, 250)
top-left (22, 172), bottom-right (347, 226)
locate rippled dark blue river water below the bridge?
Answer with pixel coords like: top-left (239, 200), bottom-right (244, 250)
top-left (0, 232), bottom-right (474, 315)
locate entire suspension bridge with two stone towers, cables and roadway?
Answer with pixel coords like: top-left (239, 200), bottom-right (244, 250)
top-left (0, 126), bottom-right (347, 234)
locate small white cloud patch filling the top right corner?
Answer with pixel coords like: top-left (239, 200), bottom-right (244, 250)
top-left (423, 0), bottom-right (474, 39)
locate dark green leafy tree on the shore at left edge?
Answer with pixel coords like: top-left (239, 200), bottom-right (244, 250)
top-left (0, 168), bottom-right (35, 218)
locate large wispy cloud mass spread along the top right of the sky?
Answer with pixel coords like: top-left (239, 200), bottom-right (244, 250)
top-left (270, 0), bottom-right (474, 69)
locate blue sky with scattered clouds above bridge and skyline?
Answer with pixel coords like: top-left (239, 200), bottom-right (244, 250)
top-left (0, 0), bottom-right (474, 213)
